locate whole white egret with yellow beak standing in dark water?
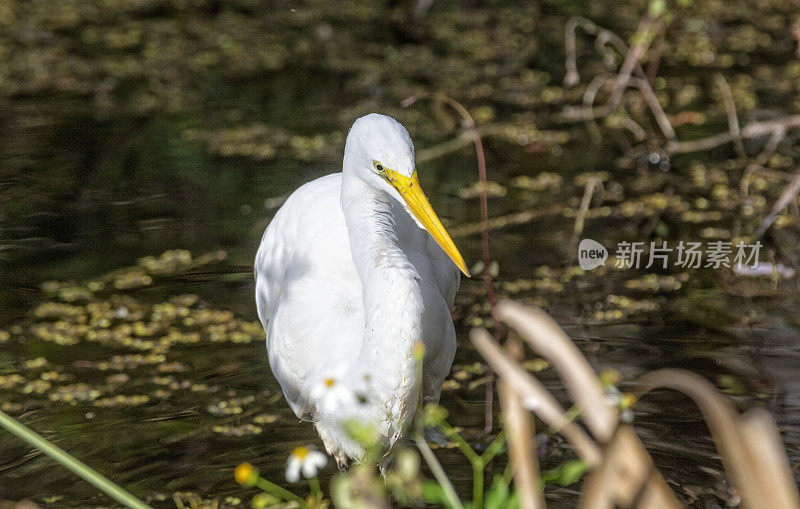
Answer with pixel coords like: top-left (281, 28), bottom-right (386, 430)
top-left (255, 114), bottom-right (469, 468)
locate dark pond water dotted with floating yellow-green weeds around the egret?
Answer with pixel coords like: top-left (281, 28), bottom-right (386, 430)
top-left (0, 1), bottom-right (800, 507)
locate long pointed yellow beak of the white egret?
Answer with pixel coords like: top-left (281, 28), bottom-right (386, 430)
top-left (380, 168), bottom-right (471, 277)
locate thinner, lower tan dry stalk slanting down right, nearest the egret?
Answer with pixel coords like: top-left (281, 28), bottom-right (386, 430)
top-left (469, 329), bottom-right (601, 466)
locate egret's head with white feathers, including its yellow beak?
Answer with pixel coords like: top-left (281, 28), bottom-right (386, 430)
top-left (344, 113), bottom-right (470, 277)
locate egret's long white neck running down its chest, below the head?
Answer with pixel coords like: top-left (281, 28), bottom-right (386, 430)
top-left (341, 172), bottom-right (423, 433)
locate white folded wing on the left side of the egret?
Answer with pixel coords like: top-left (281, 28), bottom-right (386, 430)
top-left (255, 174), bottom-right (363, 419)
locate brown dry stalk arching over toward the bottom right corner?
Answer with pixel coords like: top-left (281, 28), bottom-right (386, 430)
top-left (640, 369), bottom-right (791, 508)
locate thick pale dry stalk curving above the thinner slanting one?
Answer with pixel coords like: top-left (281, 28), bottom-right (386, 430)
top-left (497, 300), bottom-right (619, 443)
